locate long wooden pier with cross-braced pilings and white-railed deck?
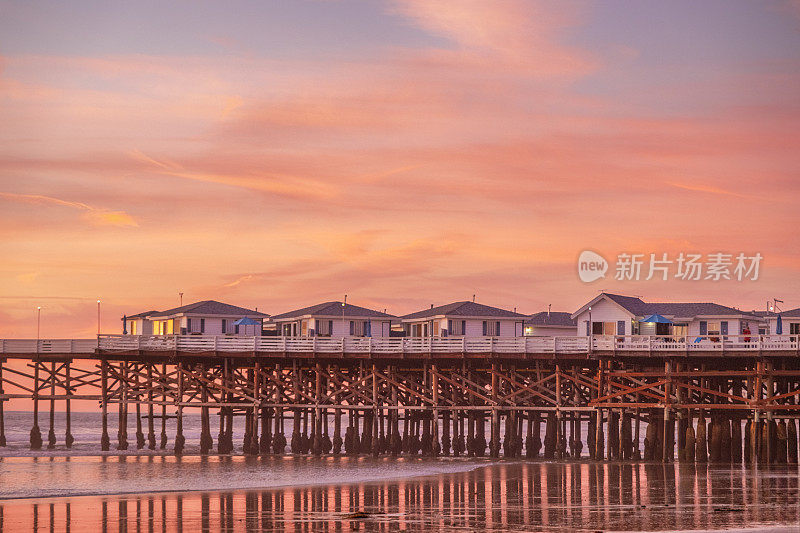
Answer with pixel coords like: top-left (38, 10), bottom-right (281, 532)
top-left (0, 335), bottom-right (800, 463)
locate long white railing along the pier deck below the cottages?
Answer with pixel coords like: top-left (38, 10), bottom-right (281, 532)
top-left (0, 335), bottom-right (800, 355)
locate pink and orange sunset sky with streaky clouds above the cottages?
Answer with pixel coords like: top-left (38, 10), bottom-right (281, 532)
top-left (0, 0), bottom-right (800, 338)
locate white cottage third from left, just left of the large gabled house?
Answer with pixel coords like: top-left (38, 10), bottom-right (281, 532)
top-left (400, 301), bottom-right (528, 337)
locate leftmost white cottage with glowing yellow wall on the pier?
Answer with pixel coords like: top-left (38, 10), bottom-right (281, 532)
top-left (123, 300), bottom-right (269, 336)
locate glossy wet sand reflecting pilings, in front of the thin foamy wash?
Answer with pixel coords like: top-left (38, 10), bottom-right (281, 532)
top-left (0, 463), bottom-right (800, 533)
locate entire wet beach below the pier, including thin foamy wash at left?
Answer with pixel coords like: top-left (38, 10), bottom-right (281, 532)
top-left (0, 450), bottom-right (800, 532)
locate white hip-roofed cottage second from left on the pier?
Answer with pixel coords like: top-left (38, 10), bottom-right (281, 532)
top-left (272, 302), bottom-right (398, 337)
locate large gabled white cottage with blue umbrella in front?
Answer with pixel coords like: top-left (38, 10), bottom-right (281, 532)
top-left (572, 292), bottom-right (763, 336)
